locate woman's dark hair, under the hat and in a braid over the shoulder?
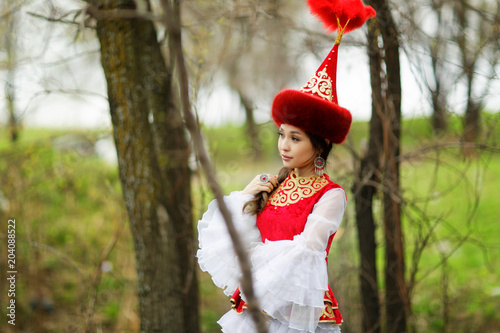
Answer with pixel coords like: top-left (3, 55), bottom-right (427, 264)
top-left (243, 132), bottom-right (333, 215)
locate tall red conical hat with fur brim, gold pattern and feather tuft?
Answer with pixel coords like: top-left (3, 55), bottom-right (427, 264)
top-left (272, 0), bottom-right (375, 143)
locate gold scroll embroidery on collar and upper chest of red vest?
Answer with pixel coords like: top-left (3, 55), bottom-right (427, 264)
top-left (268, 171), bottom-right (328, 207)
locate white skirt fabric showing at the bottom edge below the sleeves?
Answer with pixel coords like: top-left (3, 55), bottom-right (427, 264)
top-left (217, 310), bottom-right (340, 333)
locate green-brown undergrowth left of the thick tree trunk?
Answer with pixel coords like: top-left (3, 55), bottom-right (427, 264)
top-left (0, 130), bottom-right (135, 332)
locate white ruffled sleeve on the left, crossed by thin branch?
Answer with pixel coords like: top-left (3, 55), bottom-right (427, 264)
top-left (196, 192), bottom-right (261, 296)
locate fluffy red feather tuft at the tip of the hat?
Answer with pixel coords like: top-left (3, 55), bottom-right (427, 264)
top-left (307, 0), bottom-right (376, 33)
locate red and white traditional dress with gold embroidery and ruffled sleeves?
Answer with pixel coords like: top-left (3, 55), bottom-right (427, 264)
top-left (197, 171), bottom-right (346, 333)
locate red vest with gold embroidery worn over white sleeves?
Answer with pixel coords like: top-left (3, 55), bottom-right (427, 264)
top-left (231, 171), bottom-right (342, 325)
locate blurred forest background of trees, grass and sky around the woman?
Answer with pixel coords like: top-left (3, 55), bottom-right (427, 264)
top-left (0, 0), bottom-right (500, 332)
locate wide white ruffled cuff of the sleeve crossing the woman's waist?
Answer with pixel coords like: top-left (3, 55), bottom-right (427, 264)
top-left (242, 235), bottom-right (328, 332)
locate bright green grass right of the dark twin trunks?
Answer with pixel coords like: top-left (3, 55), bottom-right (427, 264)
top-left (403, 153), bottom-right (500, 331)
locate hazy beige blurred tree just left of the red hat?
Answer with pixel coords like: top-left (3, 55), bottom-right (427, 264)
top-left (222, 0), bottom-right (292, 159)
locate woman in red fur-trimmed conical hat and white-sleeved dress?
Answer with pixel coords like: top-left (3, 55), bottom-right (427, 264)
top-left (197, 0), bottom-right (375, 333)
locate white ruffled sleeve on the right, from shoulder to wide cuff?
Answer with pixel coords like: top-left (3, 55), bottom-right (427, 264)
top-left (243, 188), bottom-right (346, 332)
